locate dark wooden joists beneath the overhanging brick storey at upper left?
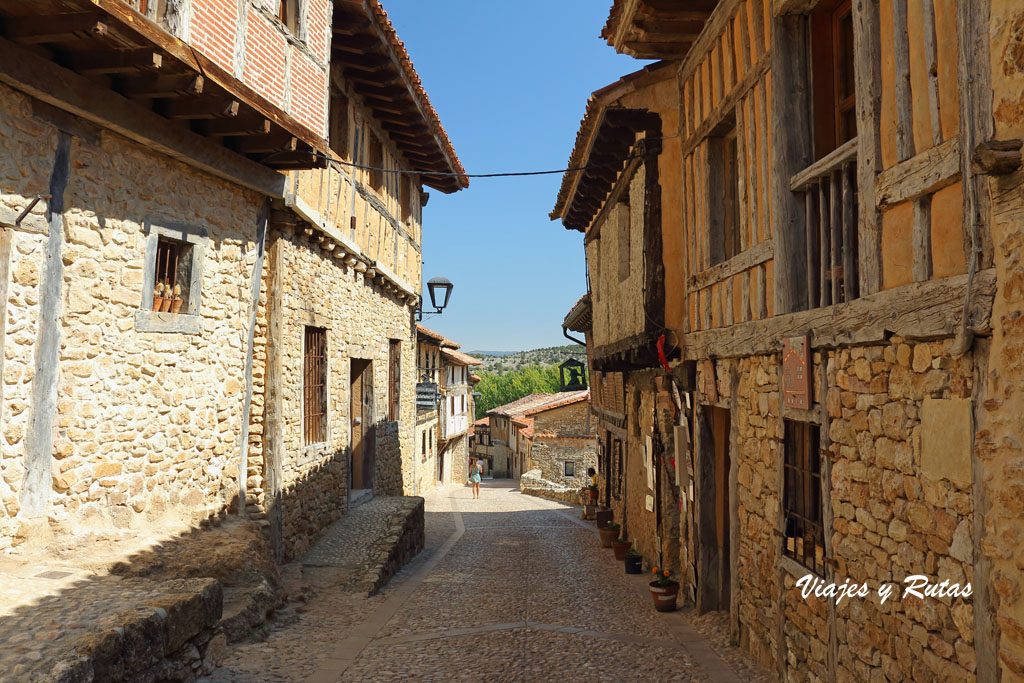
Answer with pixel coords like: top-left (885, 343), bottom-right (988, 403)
top-left (0, 0), bottom-right (327, 176)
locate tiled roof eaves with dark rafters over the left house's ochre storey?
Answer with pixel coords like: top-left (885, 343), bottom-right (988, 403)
top-left (331, 0), bottom-right (469, 193)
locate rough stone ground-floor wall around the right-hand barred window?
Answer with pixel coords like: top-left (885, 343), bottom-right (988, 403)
top-left (698, 338), bottom-right (976, 681)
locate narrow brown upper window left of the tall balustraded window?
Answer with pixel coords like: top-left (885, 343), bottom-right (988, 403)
top-left (708, 117), bottom-right (740, 265)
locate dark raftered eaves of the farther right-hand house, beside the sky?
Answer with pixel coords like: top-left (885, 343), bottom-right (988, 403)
top-left (549, 61), bottom-right (678, 232)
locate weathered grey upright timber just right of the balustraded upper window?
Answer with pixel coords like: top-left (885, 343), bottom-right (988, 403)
top-left (853, 0), bottom-right (882, 295)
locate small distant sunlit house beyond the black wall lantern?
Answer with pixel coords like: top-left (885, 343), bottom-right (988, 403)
top-left (414, 325), bottom-right (480, 494)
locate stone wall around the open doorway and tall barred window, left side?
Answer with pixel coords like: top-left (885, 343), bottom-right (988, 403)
top-left (248, 226), bottom-right (418, 557)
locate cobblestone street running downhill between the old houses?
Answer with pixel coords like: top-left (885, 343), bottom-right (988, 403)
top-left (209, 480), bottom-right (771, 683)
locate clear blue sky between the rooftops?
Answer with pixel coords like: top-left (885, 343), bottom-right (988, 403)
top-left (383, 0), bottom-right (647, 351)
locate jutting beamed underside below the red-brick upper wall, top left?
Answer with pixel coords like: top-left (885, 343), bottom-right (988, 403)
top-left (0, 0), bottom-right (327, 170)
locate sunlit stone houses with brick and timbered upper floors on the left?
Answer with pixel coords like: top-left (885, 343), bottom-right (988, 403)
top-left (0, 0), bottom-right (468, 559)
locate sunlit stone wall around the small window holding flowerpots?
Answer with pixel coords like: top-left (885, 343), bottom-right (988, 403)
top-left (0, 86), bottom-right (262, 545)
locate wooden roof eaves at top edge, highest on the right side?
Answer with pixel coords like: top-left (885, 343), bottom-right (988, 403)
top-left (601, 0), bottom-right (718, 59)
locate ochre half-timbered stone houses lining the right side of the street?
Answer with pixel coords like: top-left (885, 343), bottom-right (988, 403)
top-left (553, 0), bottom-right (1024, 681)
